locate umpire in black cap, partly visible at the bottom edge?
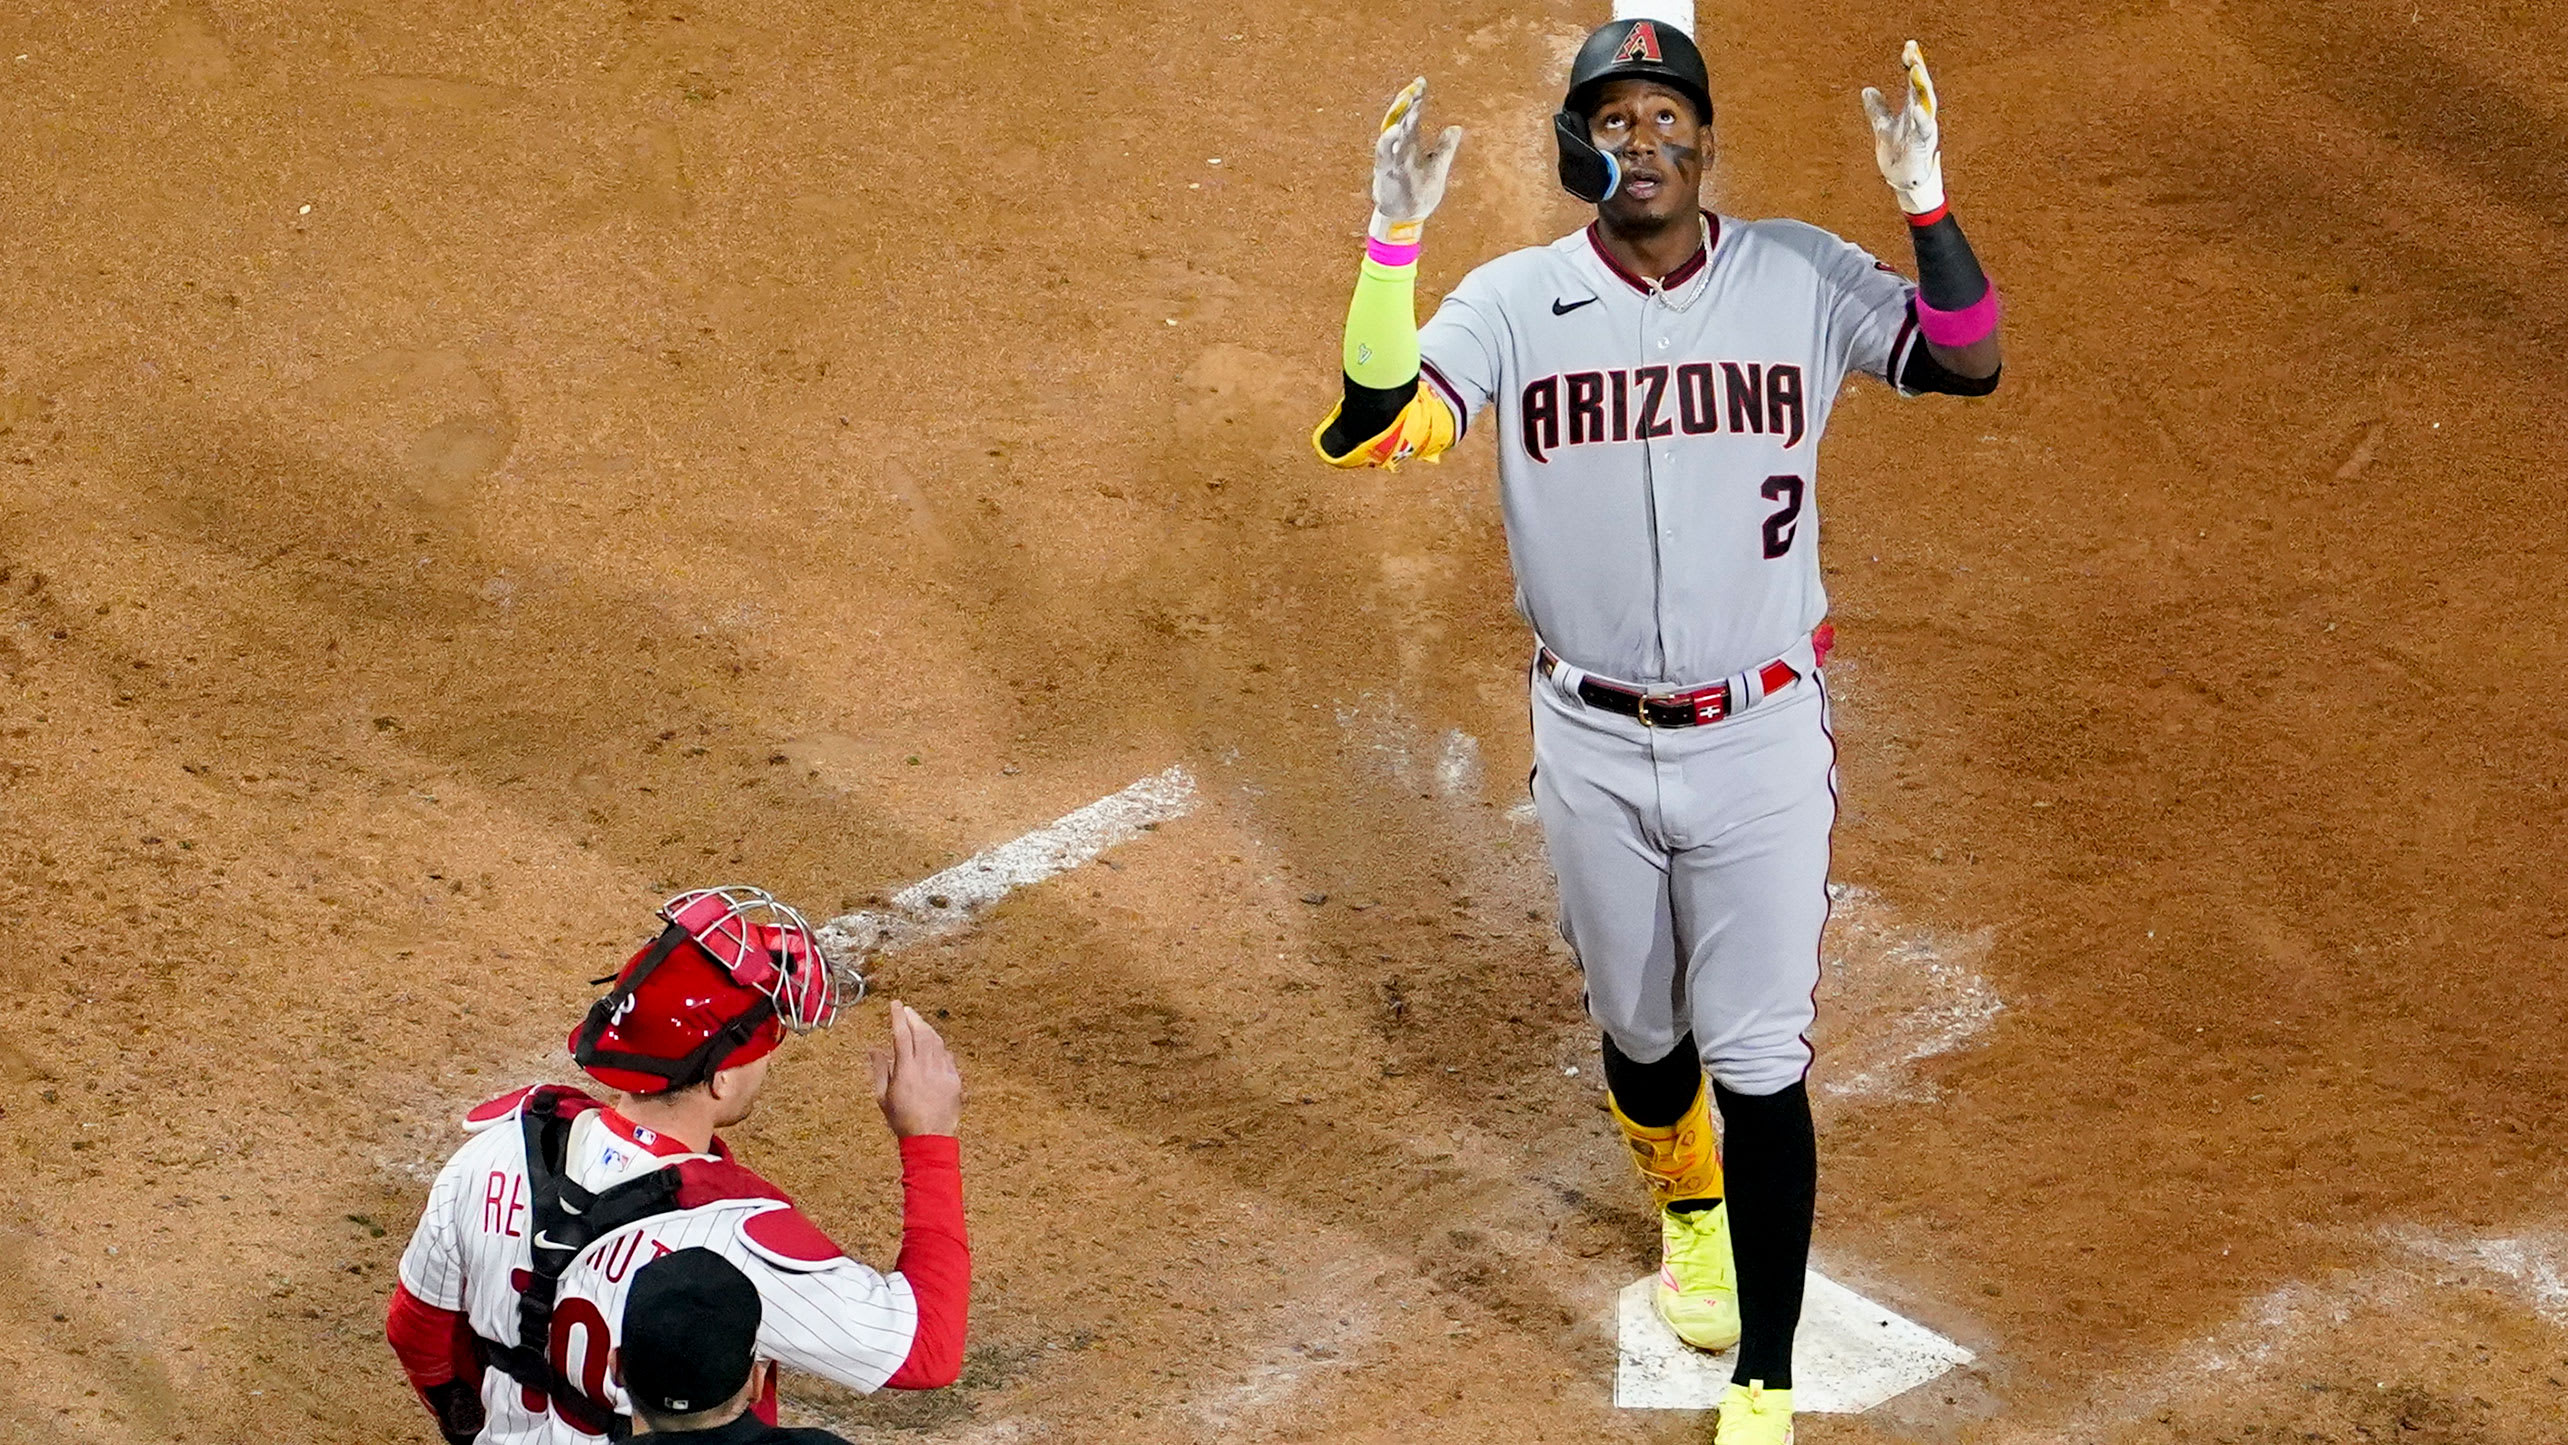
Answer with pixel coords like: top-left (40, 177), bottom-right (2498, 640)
top-left (616, 1250), bottom-right (850, 1445)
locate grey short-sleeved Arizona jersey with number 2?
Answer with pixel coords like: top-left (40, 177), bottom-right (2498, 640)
top-left (1418, 216), bottom-right (1916, 685)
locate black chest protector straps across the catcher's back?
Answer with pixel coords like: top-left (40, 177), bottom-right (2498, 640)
top-left (483, 1086), bottom-right (678, 1440)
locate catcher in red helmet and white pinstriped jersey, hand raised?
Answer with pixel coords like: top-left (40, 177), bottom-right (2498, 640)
top-left (385, 888), bottom-right (971, 1445)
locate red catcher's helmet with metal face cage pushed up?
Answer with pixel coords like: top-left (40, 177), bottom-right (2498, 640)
top-left (570, 888), bottom-right (863, 1093)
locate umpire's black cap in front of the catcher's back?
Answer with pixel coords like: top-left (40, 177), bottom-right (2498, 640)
top-left (619, 1250), bottom-right (758, 1414)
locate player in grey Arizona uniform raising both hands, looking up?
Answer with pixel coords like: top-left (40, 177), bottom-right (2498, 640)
top-left (1312, 15), bottom-right (1998, 1445)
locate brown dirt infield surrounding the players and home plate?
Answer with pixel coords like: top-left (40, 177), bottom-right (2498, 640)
top-left (0, 0), bottom-right (2568, 1442)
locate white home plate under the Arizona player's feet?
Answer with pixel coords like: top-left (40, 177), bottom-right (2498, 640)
top-left (1613, 1270), bottom-right (1972, 1414)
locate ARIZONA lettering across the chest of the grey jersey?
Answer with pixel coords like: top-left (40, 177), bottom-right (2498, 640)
top-left (1518, 362), bottom-right (1805, 462)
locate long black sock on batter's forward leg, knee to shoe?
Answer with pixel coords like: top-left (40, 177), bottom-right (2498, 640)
top-left (1715, 1088), bottom-right (1818, 1389)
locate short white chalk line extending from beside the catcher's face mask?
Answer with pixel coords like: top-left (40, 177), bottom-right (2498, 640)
top-left (819, 765), bottom-right (1197, 965)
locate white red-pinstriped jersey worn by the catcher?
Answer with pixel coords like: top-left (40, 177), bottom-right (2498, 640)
top-left (401, 1093), bottom-right (917, 1445)
